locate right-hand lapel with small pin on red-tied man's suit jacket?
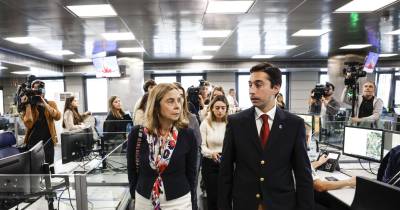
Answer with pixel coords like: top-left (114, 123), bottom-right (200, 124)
top-left (265, 107), bottom-right (286, 150)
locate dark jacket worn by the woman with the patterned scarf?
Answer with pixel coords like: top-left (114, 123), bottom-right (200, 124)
top-left (127, 126), bottom-right (198, 209)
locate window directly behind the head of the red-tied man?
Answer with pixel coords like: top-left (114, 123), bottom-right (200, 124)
top-left (236, 74), bottom-right (288, 109)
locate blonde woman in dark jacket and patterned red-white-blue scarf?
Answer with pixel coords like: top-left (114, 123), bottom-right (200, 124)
top-left (127, 83), bottom-right (198, 210)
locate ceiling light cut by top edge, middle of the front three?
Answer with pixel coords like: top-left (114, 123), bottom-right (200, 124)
top-left (206, 1), bottom-right (254, 14)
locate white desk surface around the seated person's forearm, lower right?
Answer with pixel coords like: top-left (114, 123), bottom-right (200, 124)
top-left (317, 171), bottom-right (356, 206)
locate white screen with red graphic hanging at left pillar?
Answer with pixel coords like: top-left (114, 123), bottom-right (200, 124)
top-left (93, 56), bottom-right (121, 77)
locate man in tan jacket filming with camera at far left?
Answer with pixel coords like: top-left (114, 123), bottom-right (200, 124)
top-left (21, 80), bottom-right (61, 173)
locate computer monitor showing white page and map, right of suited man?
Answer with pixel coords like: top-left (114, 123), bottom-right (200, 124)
top-left (343, 126), bottom-right (384, 162)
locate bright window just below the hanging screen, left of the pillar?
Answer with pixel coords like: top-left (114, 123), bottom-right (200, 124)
top-left (86, 78), bottom-right (108, 113)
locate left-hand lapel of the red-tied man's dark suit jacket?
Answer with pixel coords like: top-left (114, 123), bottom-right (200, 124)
top-left (242, 106), bottom-right (263, 154)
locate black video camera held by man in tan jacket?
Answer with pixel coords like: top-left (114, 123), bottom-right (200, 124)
top-left (15, 75), bottom-right (45, 112)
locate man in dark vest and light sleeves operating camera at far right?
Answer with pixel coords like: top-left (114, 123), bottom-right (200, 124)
top-left (341, 81), bottom-right (383, 128)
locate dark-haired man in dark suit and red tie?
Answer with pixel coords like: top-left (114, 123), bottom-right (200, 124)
top-left (218, 63), bottom-right (314, 210)
